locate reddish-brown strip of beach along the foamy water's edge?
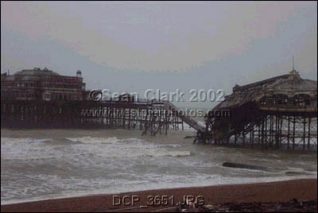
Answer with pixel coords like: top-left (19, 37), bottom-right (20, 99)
top-left (1, 179), bottom-right (317, 212)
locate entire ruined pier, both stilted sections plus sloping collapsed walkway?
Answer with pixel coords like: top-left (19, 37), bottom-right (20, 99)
top-left (1, 68), bottom-right (317, 150)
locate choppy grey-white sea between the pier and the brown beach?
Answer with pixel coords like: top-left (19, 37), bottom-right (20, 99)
top-left (1, 129), bottom-right (317, 204)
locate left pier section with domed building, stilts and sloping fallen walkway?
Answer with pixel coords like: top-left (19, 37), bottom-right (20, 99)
top-left (1, 68), bottom-right (204, 135)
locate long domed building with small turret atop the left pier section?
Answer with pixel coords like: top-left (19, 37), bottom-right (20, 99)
top-left (1, 68), bottom-right (85, 101)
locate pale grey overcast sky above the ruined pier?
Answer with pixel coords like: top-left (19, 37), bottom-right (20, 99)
top-left (1, 2), bottom-right (317, 107)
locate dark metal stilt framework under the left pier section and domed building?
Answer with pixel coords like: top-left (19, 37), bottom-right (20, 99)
top-left (1, 100), bottom-right (189, 135)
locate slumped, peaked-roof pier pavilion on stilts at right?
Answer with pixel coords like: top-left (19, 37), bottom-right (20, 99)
top-left (204, 69), bottom-right (317, 150)
